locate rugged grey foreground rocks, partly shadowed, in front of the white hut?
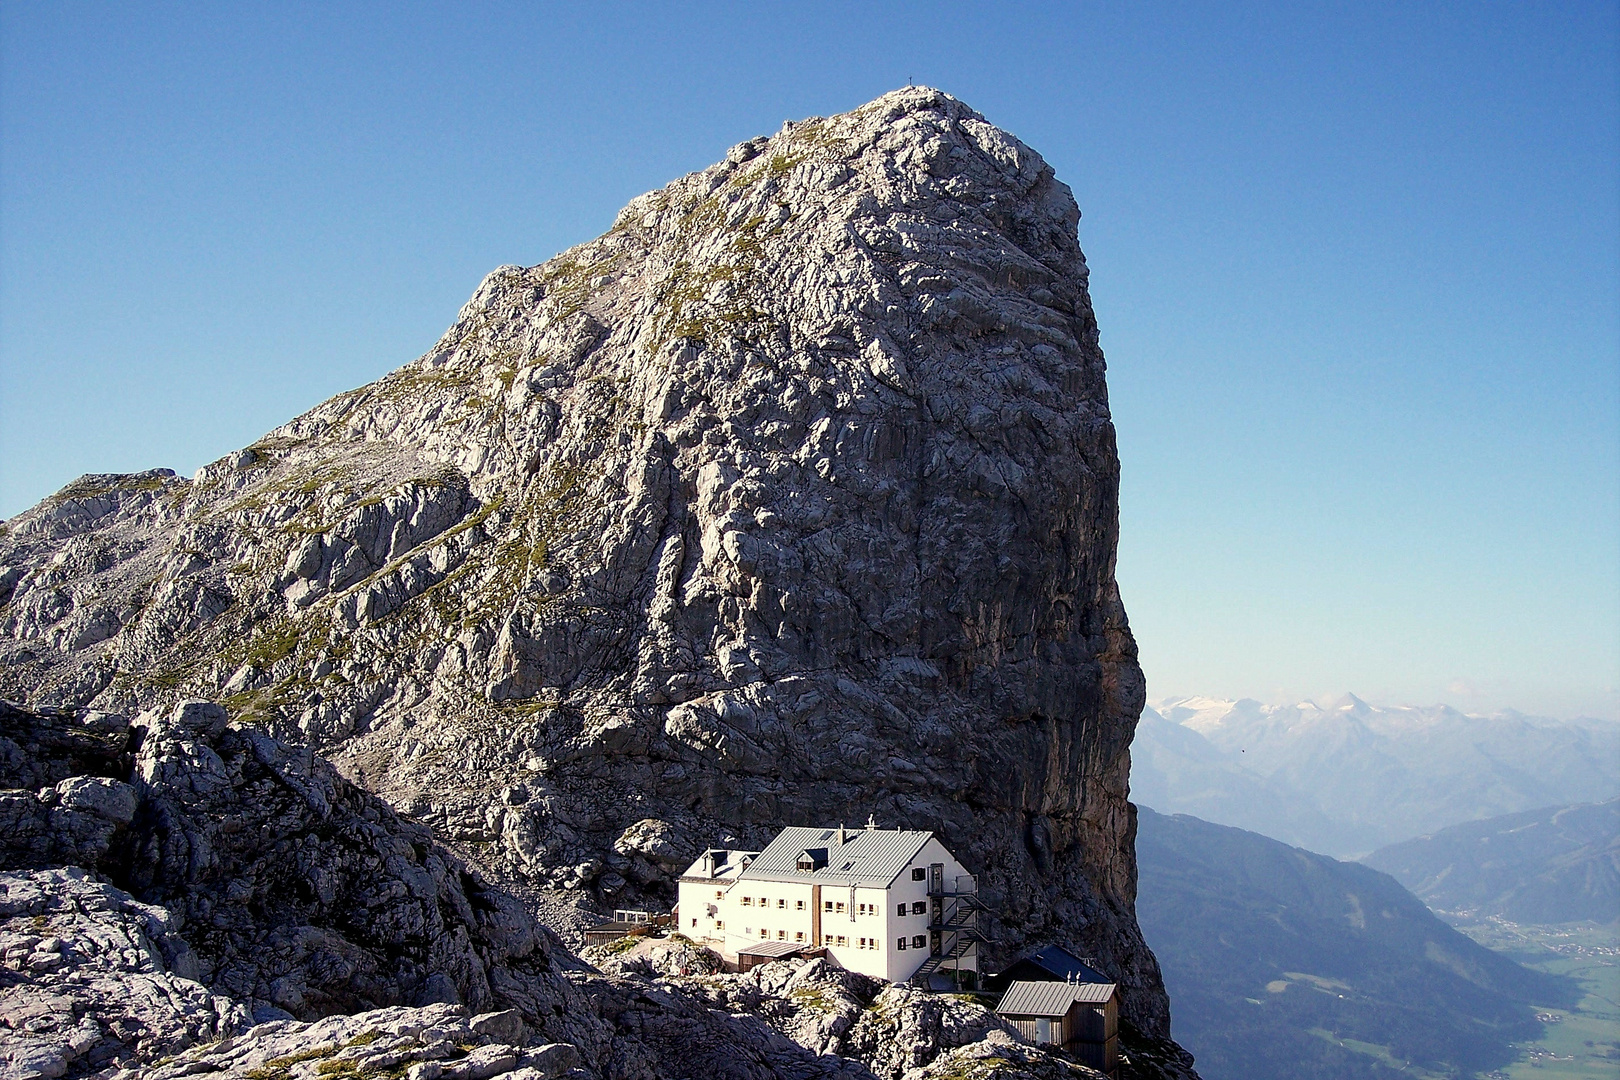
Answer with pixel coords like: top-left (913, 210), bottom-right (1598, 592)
top-left (0, 701), bottom-right (1191, 1080)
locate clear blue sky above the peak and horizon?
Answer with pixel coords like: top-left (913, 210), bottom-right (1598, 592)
top-left (0, 2), bottom-right (1620, 716)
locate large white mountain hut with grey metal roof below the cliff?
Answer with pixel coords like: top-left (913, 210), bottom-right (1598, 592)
top-left (676, 823), bottom-right (980, 983)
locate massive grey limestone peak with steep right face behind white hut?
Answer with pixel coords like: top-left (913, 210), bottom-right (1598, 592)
top-left (0, 87), bottom-right (1168, 1035)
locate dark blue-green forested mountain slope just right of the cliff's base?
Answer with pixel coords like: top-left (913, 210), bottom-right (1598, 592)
top-left (1137, 808), bottom-right (1578, 1080)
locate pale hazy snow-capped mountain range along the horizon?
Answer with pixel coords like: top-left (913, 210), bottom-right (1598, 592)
top-left (1131, 695), bottom-right (1620, 858)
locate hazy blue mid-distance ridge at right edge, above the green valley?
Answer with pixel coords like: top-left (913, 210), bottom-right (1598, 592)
top-left (1364, 798), bottom-right (1620, 923)
